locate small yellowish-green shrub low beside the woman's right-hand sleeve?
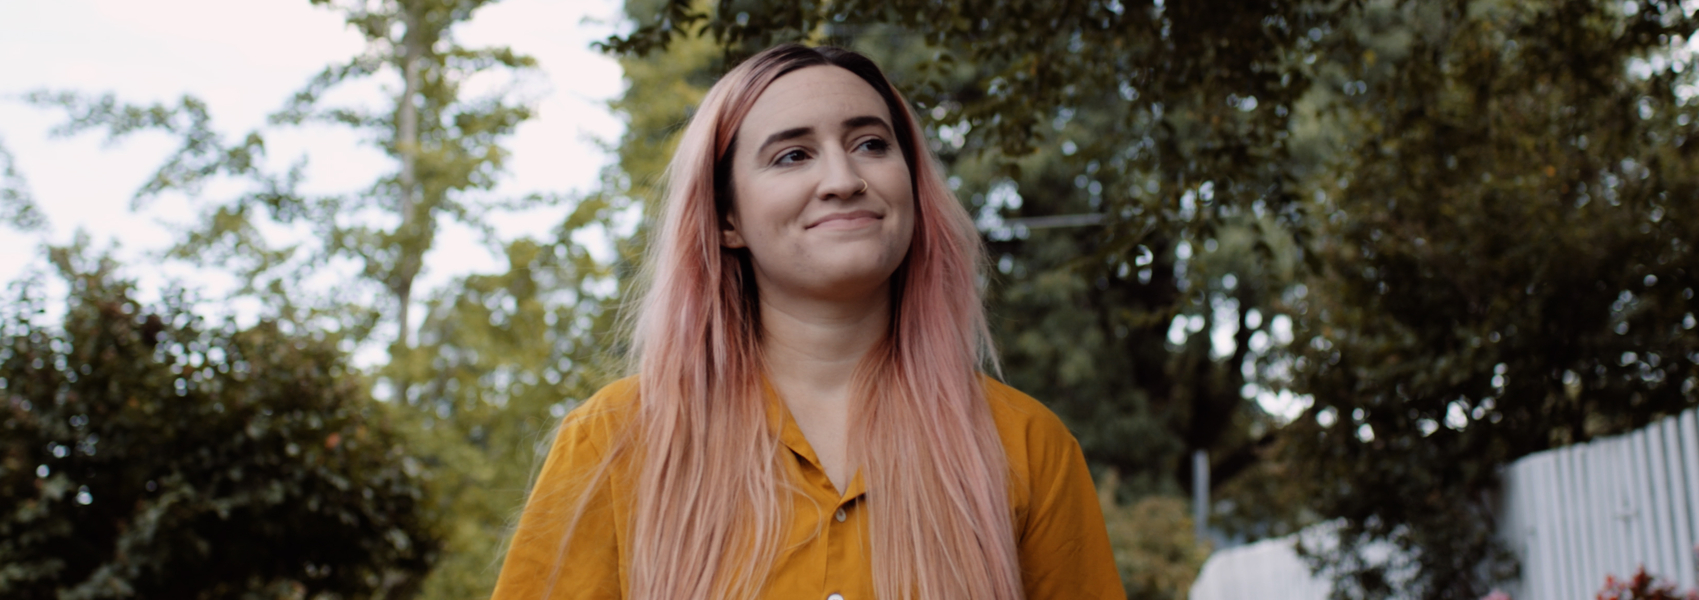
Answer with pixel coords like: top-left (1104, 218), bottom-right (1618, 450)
top-left (1098, 471), bottom-right (1210, 600)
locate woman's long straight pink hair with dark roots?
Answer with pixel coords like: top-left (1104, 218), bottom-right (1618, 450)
top-left (591, 44), bottom-right (1023, 600)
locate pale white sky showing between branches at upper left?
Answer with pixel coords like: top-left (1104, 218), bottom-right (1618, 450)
top-left (0, 0), bottom-right (624, 322)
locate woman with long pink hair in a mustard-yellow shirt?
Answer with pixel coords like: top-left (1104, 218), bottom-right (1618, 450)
top-left (496, 44), bottom-right (1123, 600)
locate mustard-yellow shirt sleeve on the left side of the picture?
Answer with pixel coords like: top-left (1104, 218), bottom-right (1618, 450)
top-left (491, 386), bottom-right (638, 600)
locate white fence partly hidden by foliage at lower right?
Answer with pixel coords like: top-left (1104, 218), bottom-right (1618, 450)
top-left (1191, 410), bottom-right (1699, 600)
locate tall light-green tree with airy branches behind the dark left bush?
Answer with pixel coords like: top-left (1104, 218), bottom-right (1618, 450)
top-left (21, 0), bottom-right (618, 598)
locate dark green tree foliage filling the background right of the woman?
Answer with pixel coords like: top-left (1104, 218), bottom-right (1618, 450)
top-left (605, 0), bottom-right (1699, 598)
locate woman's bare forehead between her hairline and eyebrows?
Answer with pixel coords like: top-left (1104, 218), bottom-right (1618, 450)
top-left (737, 65), bottom-right (890, 143)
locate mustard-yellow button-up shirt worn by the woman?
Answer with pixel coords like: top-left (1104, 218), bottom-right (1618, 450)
top-left (494, 377), bottom-right (1126, 600)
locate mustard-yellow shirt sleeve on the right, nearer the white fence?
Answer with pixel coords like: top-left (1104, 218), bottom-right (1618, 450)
top-left (1018, 415), bottom-right (1126, 600)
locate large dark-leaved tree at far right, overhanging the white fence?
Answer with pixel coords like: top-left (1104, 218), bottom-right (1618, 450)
top-left (1291, 0), bottom-right (1699, 598)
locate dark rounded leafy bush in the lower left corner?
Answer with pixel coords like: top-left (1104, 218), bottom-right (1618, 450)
top-left (0, 244), bottom-right (438, 598)
